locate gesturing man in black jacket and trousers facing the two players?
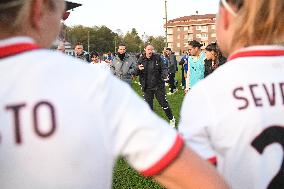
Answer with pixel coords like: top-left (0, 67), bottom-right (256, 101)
top-left (137, 45), bottom-right (175, 127)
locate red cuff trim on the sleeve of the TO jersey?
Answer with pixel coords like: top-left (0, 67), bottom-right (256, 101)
top-left (141, 135), bottom-right (184, 177)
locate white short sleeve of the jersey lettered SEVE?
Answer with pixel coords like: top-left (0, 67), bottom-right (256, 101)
top-left (179, 85), bottom-right (216, 163)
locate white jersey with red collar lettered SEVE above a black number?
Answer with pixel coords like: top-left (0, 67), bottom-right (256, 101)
top-left (179, 46), bottom-right (284, 189)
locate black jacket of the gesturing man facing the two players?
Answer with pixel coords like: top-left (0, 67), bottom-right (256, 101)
top-left (136, 54), bottom-right (168, 91)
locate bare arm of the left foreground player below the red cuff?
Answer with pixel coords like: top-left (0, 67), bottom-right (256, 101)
top-left (154, 147), bottom-right (229, 189)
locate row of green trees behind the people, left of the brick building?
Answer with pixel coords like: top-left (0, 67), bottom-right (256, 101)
top-left (65, 25), bottom-right (165, 53)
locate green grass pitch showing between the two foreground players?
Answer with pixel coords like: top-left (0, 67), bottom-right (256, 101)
top-left (112, 70), bottom-right (184, 189)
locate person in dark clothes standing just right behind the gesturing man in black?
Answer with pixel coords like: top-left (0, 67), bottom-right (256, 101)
top-left (166, 48), bottom-right (177, 95)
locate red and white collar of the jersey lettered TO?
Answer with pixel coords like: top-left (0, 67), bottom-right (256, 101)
top-left (0, 37), bottom-right (39, 58)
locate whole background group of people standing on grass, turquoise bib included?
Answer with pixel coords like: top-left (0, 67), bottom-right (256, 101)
top-left (69, 40), bottom-right (229, 127)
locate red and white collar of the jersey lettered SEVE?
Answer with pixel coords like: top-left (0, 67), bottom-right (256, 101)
top-left (228, 46), bottom-right (284, 61)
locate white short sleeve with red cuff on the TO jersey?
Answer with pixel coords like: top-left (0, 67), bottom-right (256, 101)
top-left (96, 72), bottom-right (183, 176)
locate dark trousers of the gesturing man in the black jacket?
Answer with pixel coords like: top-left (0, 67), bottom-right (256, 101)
top-left (144, 88), bottom-right (173, 120)
